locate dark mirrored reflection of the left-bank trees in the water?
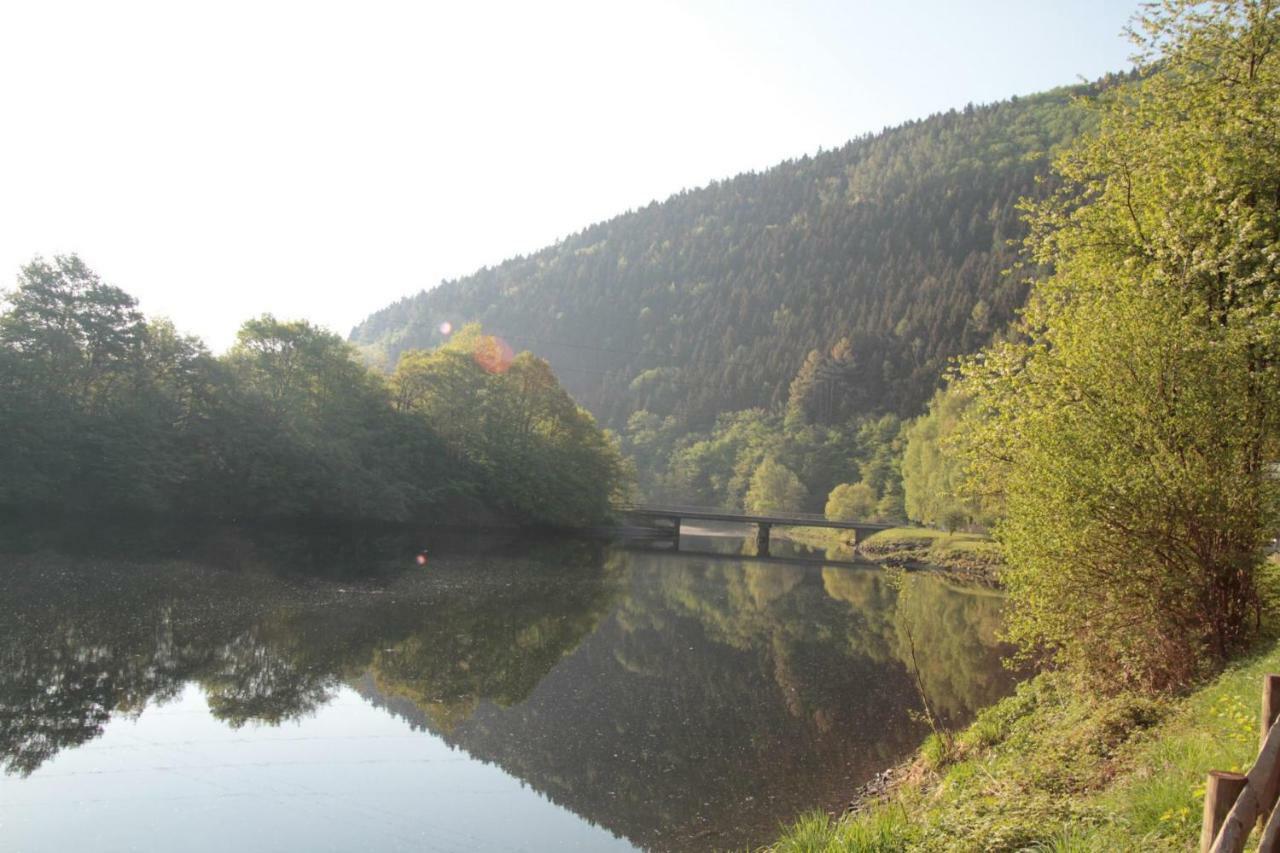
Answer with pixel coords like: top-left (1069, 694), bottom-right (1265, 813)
top-left (0, 535), bottom-right (612, 775)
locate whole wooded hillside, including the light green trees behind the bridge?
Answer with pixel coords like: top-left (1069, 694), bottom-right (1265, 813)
top-left (351, 77), bottom-right (1129, 512)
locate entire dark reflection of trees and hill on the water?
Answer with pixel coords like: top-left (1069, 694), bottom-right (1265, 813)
top-left (0, 533), bottom-right (1010, 849)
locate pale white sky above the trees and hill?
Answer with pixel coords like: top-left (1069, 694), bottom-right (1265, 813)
top-left (0, 0), bottom-right (1138, 350)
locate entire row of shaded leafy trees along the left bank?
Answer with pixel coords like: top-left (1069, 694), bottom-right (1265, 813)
top-left (0, 256), bottom-right (622, 525)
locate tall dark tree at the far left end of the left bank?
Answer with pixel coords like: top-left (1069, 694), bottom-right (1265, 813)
top-left (0, 255), bottom-right (169, 508)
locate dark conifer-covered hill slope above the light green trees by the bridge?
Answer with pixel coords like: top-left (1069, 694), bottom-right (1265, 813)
top-left (351, 77), bottom-right (1126, 428)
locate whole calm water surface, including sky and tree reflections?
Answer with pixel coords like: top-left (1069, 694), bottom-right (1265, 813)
top-left (0, 522), bottom-right (1011, 852)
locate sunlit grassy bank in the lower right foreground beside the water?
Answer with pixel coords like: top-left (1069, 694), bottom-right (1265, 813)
top-left (773, 640), bottom-right (1280, 853)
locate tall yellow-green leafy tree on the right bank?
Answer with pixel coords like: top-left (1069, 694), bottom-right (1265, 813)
top-left (963, 0), bottom-right (1280, 688)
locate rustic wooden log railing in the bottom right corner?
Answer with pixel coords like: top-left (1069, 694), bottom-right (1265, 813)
top-left (1201, 675), bottom-right (1280, 853)
